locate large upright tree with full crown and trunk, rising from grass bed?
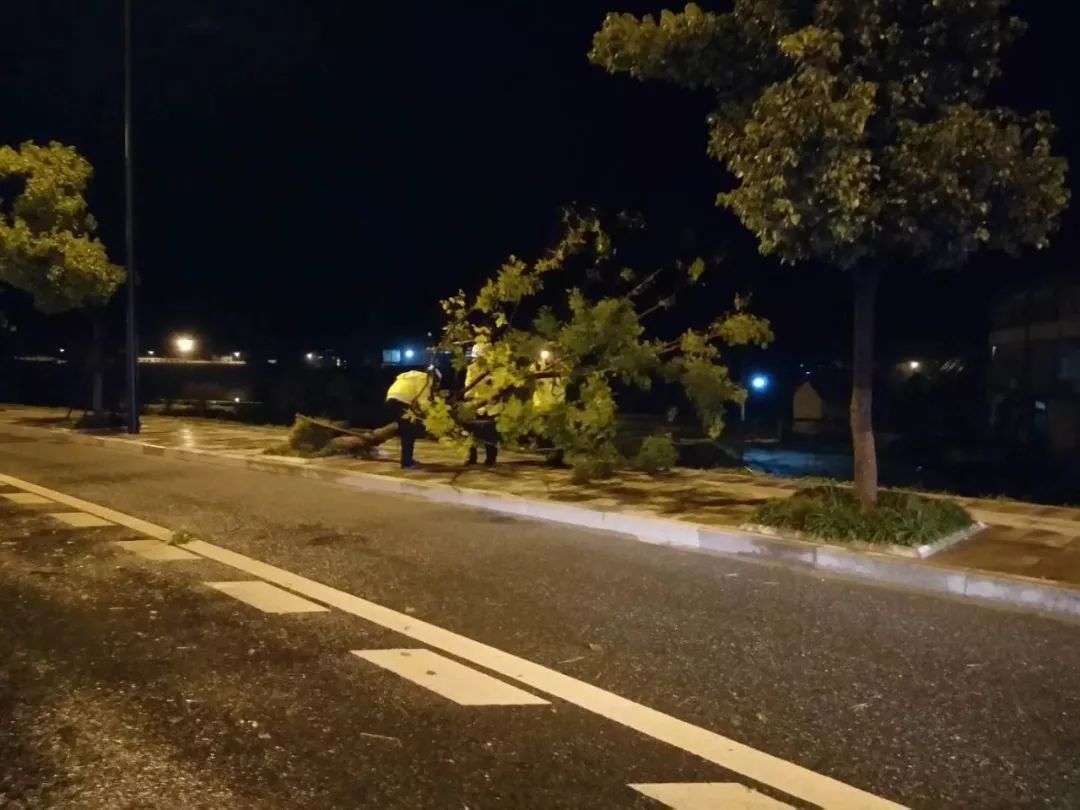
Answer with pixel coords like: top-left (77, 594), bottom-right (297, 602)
top-left (589, 0), bottom-right (1068, 507)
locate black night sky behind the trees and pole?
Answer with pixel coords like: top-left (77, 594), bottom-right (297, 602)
top-left (0, 0), bottom-right (1080, 359)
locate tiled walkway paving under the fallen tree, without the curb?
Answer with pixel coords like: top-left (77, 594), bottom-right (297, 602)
top-left (6, 406), bottom-right (1080, 585)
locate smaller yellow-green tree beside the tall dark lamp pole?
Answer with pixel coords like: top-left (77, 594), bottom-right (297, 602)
top-left (0, 141), bottom-right (124, 410)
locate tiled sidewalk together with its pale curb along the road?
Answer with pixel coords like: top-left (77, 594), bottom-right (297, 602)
top-left (6, 406), bottom-right (1080, 611)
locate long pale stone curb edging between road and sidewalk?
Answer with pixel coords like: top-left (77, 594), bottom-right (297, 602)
top-left (6, 424), bottom-right (1080, 618)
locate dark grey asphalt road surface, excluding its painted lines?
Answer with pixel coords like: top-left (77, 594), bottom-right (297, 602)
top-left (6, 432), bottom-right (1080, 810)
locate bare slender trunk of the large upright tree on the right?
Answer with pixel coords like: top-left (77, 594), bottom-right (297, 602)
top-left (851, 266), bottom-right (881, 509)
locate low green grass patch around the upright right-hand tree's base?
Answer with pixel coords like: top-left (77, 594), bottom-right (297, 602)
top-left (753, 486), bottom-right (974, 546)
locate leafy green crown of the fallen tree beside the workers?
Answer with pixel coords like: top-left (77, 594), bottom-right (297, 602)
top-left (423, 211), bottom-right (772, 480)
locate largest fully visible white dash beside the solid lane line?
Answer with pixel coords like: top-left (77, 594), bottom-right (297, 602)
top-left (352, 649), bottom-right (549, 706)
